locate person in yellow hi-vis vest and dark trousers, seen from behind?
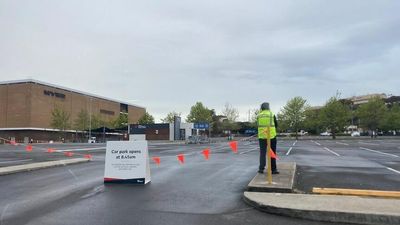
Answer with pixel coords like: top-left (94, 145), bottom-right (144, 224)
top-left (257, 102), bottom-right (279, 174)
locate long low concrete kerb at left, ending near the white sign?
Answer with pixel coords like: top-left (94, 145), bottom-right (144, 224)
top-left (0, 158), bottom-right (90, 176)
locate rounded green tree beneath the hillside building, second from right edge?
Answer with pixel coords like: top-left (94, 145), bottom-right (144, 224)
top-left (357, 97), bottom-right (387, 131)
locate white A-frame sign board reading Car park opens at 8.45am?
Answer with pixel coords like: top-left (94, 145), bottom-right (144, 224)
top-left (104, 141), bottom-right (151, 184)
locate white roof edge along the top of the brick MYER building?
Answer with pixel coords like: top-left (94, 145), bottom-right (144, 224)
top-left (0, 79), bottom-right (146, 109)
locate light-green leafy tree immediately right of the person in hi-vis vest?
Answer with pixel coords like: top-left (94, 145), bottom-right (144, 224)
top-left (280, 96), bottom-right (307, 139)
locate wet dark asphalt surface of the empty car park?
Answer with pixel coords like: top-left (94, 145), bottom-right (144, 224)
top-left (0, 140), bottom-right (400, 225)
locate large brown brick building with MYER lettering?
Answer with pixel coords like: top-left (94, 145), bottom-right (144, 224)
top-left (0, 79), bottom-right (146, 141)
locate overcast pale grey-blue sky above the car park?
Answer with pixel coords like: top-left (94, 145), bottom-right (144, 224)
top-left (0, 0), bottom-right (400, 120)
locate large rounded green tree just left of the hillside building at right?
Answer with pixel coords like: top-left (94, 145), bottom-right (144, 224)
top-left (320, 95), bottom-right (350, 139)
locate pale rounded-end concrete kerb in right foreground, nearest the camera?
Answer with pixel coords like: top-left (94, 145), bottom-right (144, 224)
top-left (244, 192), bottom-right (400, 225)
